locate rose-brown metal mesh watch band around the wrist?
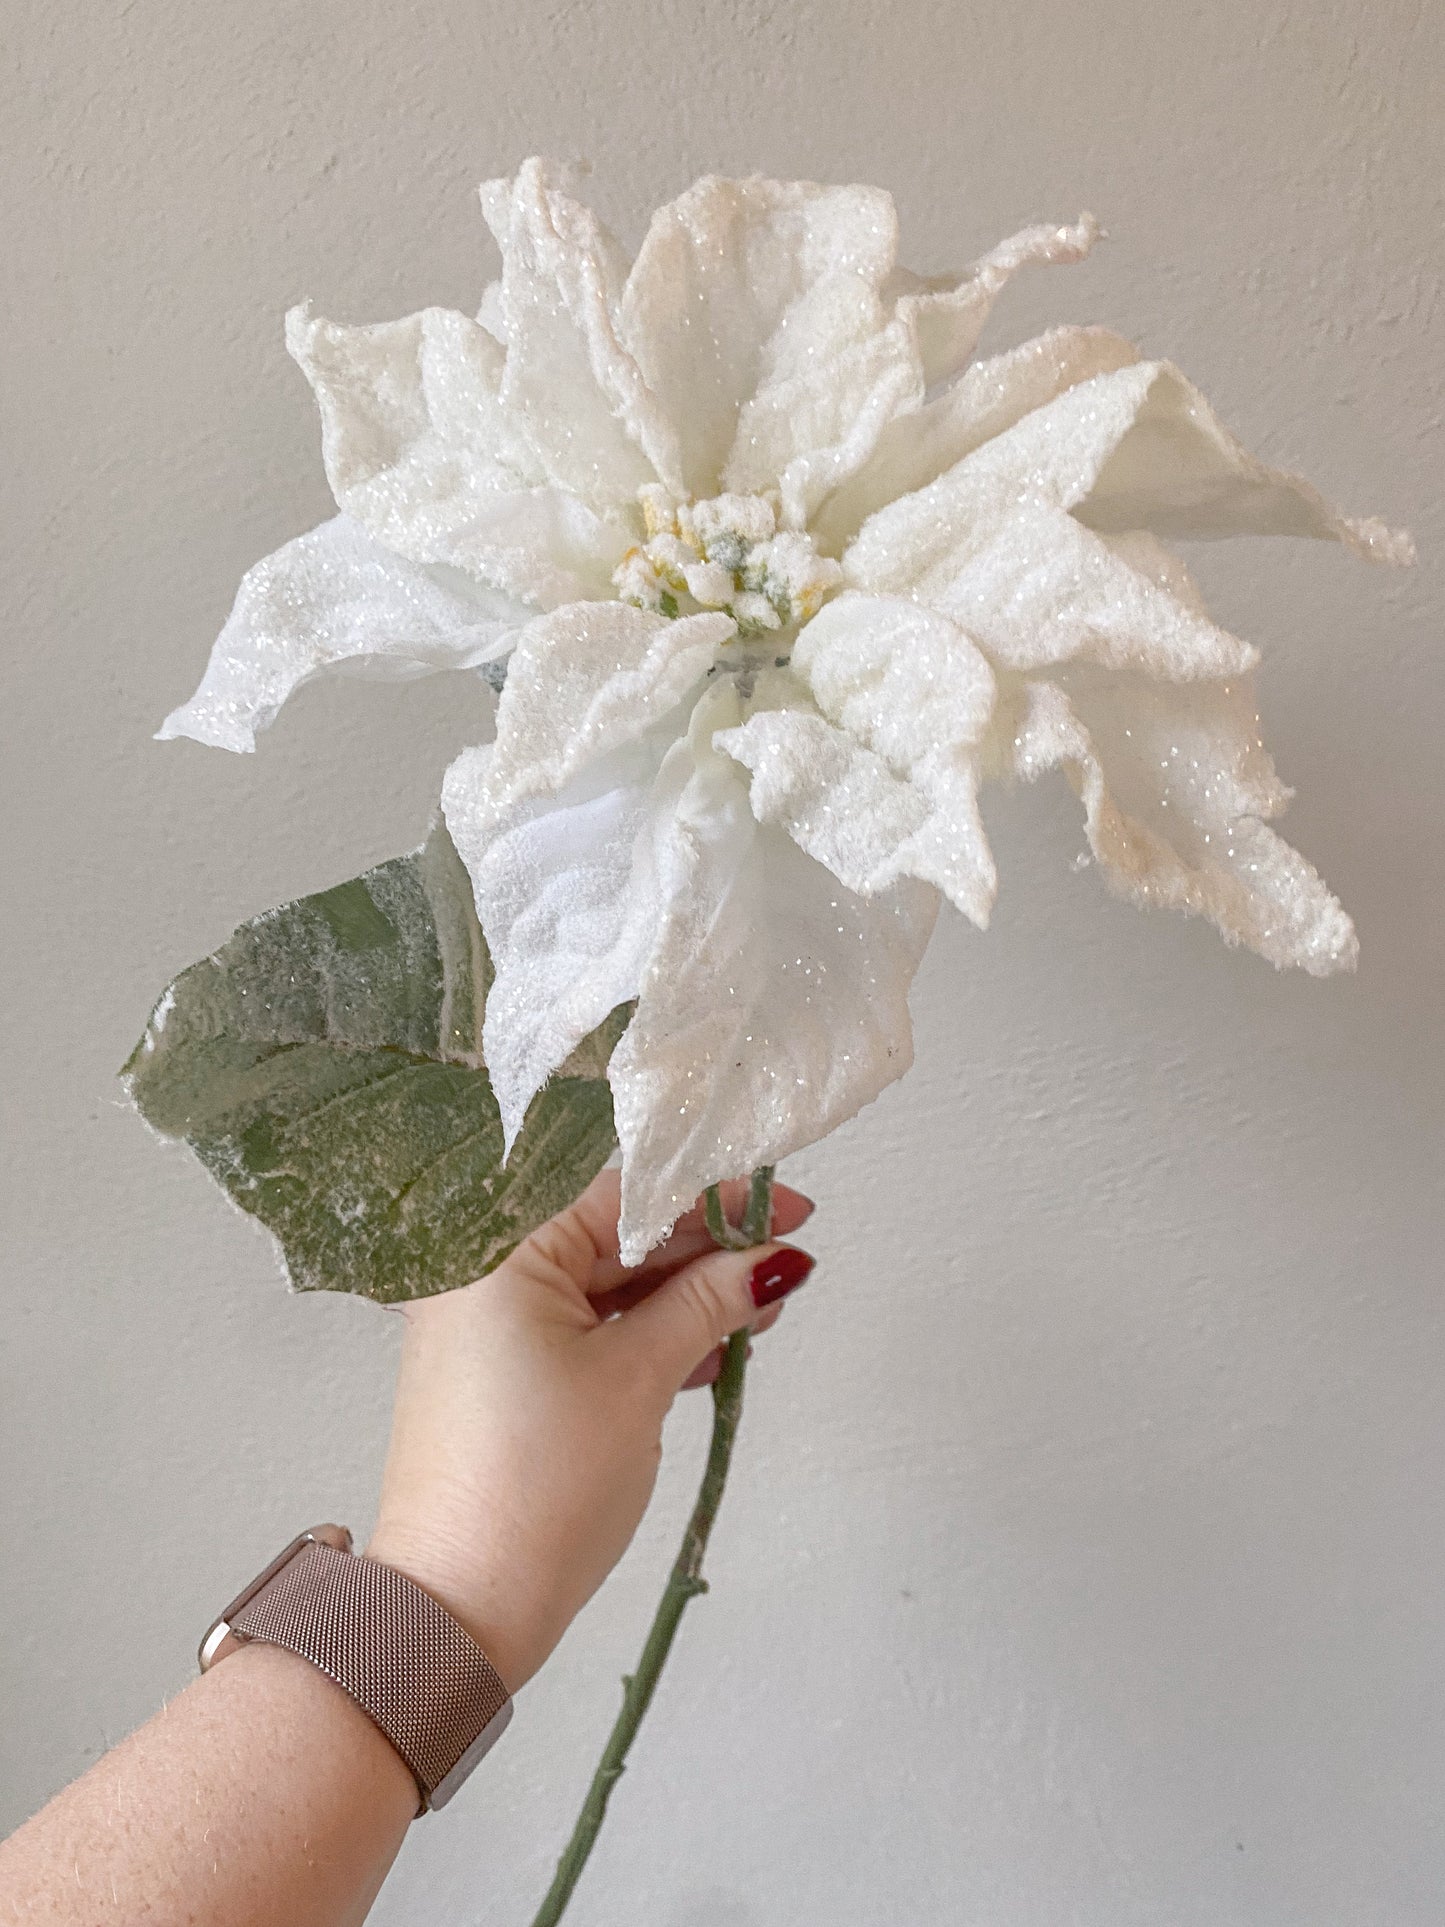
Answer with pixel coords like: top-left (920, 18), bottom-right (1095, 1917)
top-left (200, 1526), bottom-right (512, 1811)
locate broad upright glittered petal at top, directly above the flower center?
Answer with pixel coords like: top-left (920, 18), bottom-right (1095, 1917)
top-left (620, 177), bottom-right (898, 495)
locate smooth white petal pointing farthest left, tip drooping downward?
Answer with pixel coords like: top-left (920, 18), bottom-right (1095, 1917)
top-left (156, 515), bottom-right (532, 750)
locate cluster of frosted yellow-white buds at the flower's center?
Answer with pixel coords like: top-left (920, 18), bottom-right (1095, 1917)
top-left (613, 484), bottom-right (842, 636)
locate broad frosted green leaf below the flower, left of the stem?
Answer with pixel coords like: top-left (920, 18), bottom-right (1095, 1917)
top-left (121, 825), bottom-right (628, 1303)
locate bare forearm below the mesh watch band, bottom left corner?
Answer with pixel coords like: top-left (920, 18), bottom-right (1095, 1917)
top-left (0, 1646), bottom-right (416, 1927)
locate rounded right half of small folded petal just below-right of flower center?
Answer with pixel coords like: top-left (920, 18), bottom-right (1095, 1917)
top-left (792, 595), bottom-right (998, 927)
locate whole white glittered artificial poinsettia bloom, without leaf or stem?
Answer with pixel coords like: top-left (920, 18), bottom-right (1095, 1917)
top-left (162, 160), bottom-right (1408, 1260)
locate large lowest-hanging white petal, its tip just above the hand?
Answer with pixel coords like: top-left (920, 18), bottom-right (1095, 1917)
top-left (609, 688), bottom-right (938, 1264)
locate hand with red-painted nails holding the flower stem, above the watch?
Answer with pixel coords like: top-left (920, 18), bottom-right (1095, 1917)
top-left (366, 1172), bottom-right (813, 1692)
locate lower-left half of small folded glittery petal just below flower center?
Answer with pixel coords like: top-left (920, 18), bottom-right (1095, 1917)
top-left (715, 709), bottom-right (992, 923)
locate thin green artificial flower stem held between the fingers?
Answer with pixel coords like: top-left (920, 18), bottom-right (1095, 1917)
top-left (532, 1164), bottom-right (773, 1927)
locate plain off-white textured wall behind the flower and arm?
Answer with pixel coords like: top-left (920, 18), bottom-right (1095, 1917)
top-left (0, 0), bottom-right (1445, 1927)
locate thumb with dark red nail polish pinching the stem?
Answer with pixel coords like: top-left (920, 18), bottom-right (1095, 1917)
top-left (611, 1245), bottom-right (817, 1389)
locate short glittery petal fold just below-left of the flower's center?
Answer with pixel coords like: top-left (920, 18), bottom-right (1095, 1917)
top-left (476, 601), bottom-right (734, 832)
